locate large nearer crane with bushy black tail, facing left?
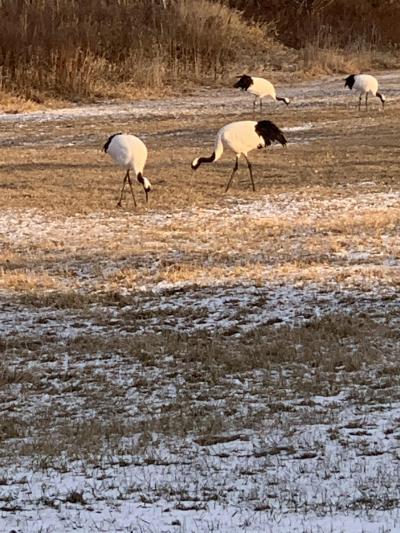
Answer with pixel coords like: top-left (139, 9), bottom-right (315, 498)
top-left (192, 120), bottom-right (287, 192)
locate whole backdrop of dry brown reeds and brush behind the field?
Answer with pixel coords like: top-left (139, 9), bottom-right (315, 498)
top-left (0, 0), bottom-right (399, 105)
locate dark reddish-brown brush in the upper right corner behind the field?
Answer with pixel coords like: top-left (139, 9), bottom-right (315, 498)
top-left (229, 0), bottom-right (400, 75)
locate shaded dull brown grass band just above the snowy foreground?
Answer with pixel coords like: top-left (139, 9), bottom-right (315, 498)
top-left (0, 311), bottom-right (399, 462)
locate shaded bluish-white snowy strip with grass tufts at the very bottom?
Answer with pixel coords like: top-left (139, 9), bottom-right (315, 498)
top-left (0, 404), bottom-right (400, 533)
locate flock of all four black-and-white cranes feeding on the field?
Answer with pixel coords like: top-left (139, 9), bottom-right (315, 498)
top-left (103, 74), bottom-right (386, 207)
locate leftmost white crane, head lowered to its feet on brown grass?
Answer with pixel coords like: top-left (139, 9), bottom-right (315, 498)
top-left (103, 133), bottom-right (152, 207)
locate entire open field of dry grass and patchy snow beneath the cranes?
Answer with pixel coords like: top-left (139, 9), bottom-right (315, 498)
top-left (0, 72), bottom-right (400, 533)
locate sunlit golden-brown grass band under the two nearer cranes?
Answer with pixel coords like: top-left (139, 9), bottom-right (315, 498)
top-left (0, 94), bottom-right (400, 293)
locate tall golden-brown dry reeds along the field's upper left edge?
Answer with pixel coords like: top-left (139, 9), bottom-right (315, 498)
top-left (0, 0), bottom-right (272, 101)
